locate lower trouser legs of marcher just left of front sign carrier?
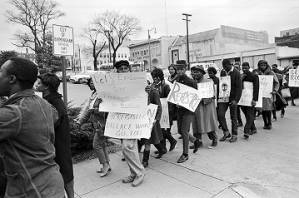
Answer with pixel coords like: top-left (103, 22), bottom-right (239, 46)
top-left (92, 133), bottom-right (109, 164)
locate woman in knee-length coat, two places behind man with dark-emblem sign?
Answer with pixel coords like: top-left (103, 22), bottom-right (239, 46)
top-left (257, 60), bottom-right (279, 130)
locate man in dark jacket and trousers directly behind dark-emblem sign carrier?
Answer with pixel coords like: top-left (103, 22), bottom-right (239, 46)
top-left (241, 62), bottom-right (259, 139)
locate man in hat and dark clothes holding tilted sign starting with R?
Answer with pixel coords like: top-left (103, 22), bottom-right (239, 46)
top-left (175, 60), bottom-right (197, 163)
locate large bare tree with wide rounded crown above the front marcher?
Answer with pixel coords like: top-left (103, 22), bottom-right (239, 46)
top-left (94, 11), bottom-right (141, 64)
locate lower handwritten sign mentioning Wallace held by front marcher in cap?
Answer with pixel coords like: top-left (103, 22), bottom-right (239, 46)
top-left (104, 104), bottom-right (158, 139)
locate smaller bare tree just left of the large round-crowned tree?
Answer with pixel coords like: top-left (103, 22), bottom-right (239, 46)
top-left (82, 25), bottom-right (106, 71)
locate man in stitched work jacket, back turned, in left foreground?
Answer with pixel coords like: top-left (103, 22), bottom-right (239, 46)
top-left (0, 58), bottom-right (64, 198)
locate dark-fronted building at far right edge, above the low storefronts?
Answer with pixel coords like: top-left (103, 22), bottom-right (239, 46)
top-left (275, 28), bottom-right (299, 48)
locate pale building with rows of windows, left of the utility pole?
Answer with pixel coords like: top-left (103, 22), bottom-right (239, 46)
top-left (129, 36), bottom-right (177, 70)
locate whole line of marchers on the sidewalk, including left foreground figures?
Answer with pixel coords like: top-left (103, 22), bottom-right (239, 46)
top-left (0, 58), bottom-right (298, 198)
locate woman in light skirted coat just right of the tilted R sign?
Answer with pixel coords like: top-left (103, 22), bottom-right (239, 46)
top-left (191, 65), bottom-right (217, 153)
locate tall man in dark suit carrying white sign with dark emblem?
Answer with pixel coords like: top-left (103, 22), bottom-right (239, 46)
top-left (218, 59), bottom-right (242, 142)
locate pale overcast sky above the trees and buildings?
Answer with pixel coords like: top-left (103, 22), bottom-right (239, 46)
top-left (0, 0), bottom-right (299, 52)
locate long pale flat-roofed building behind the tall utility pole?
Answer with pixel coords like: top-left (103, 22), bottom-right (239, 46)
top-left (169, 25), bottom-right (269, 63)
